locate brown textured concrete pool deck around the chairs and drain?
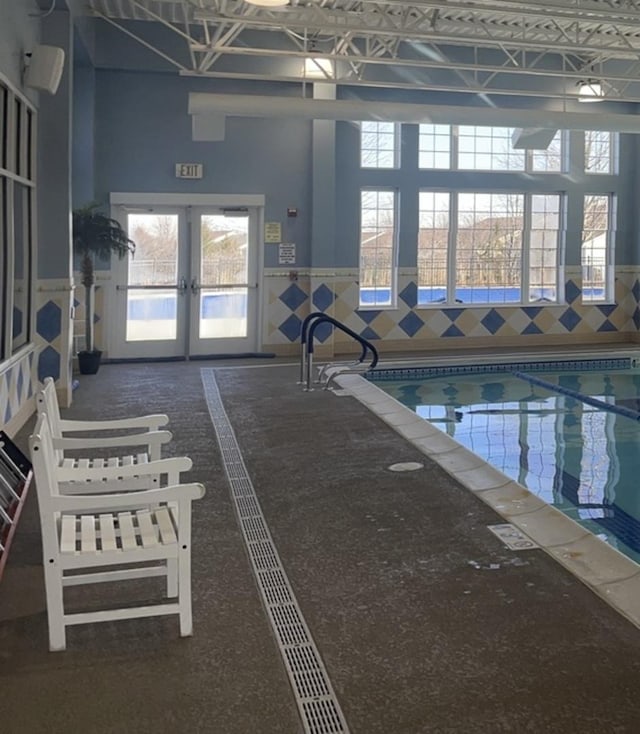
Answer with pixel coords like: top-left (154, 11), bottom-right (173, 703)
top-left (0, 360), bottom-right (640, 734)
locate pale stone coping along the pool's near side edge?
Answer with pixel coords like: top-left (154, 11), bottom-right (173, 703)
top-left (333, 372), bottom-right (640, 628)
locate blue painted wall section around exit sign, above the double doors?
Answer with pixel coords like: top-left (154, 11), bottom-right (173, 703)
top-left (95, 71), bottom-right (311, 266)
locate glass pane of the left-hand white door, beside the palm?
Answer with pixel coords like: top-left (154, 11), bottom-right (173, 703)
top-left (126, 214), bottom-right (178, 341)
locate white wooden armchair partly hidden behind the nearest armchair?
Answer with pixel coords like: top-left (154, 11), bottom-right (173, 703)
top-left (36, 377), bottom-right (175, 494)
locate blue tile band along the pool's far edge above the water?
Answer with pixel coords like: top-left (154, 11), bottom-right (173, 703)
top-left (364, 357), bottom-right (635, 382)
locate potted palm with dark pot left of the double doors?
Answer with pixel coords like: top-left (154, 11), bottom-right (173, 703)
top-left (72, 202), bottom-right (136, 375)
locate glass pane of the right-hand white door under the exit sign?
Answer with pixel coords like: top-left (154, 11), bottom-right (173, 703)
top-left (199, 214), bottom-right (249, 339)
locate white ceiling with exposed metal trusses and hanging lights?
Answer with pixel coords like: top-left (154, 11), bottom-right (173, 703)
top-left (81, 0), bottom-right (640, 102)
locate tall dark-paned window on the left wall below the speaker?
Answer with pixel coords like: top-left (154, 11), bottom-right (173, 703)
top-left (0, 78), bottom-right (35, 359)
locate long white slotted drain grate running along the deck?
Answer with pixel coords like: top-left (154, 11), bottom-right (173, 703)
top-left (201, 369), bottom-right (349, 734)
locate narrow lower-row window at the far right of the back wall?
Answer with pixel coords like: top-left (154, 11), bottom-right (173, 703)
top-left (582, 194), bottom-right (615, 302)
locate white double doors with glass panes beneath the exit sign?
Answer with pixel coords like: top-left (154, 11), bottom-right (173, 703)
top-left (109, 200), bottom-right (260, 358)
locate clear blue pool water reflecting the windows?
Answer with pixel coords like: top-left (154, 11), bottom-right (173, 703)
top-left (377, 370), bottom-right (640, 563)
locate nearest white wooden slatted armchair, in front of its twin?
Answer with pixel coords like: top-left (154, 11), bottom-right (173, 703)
top-left (29, 413), bottom-right (204, 650)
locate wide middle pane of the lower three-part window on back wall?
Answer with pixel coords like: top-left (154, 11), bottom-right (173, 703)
top-left (456, 193), bottom-right (524, 303)
